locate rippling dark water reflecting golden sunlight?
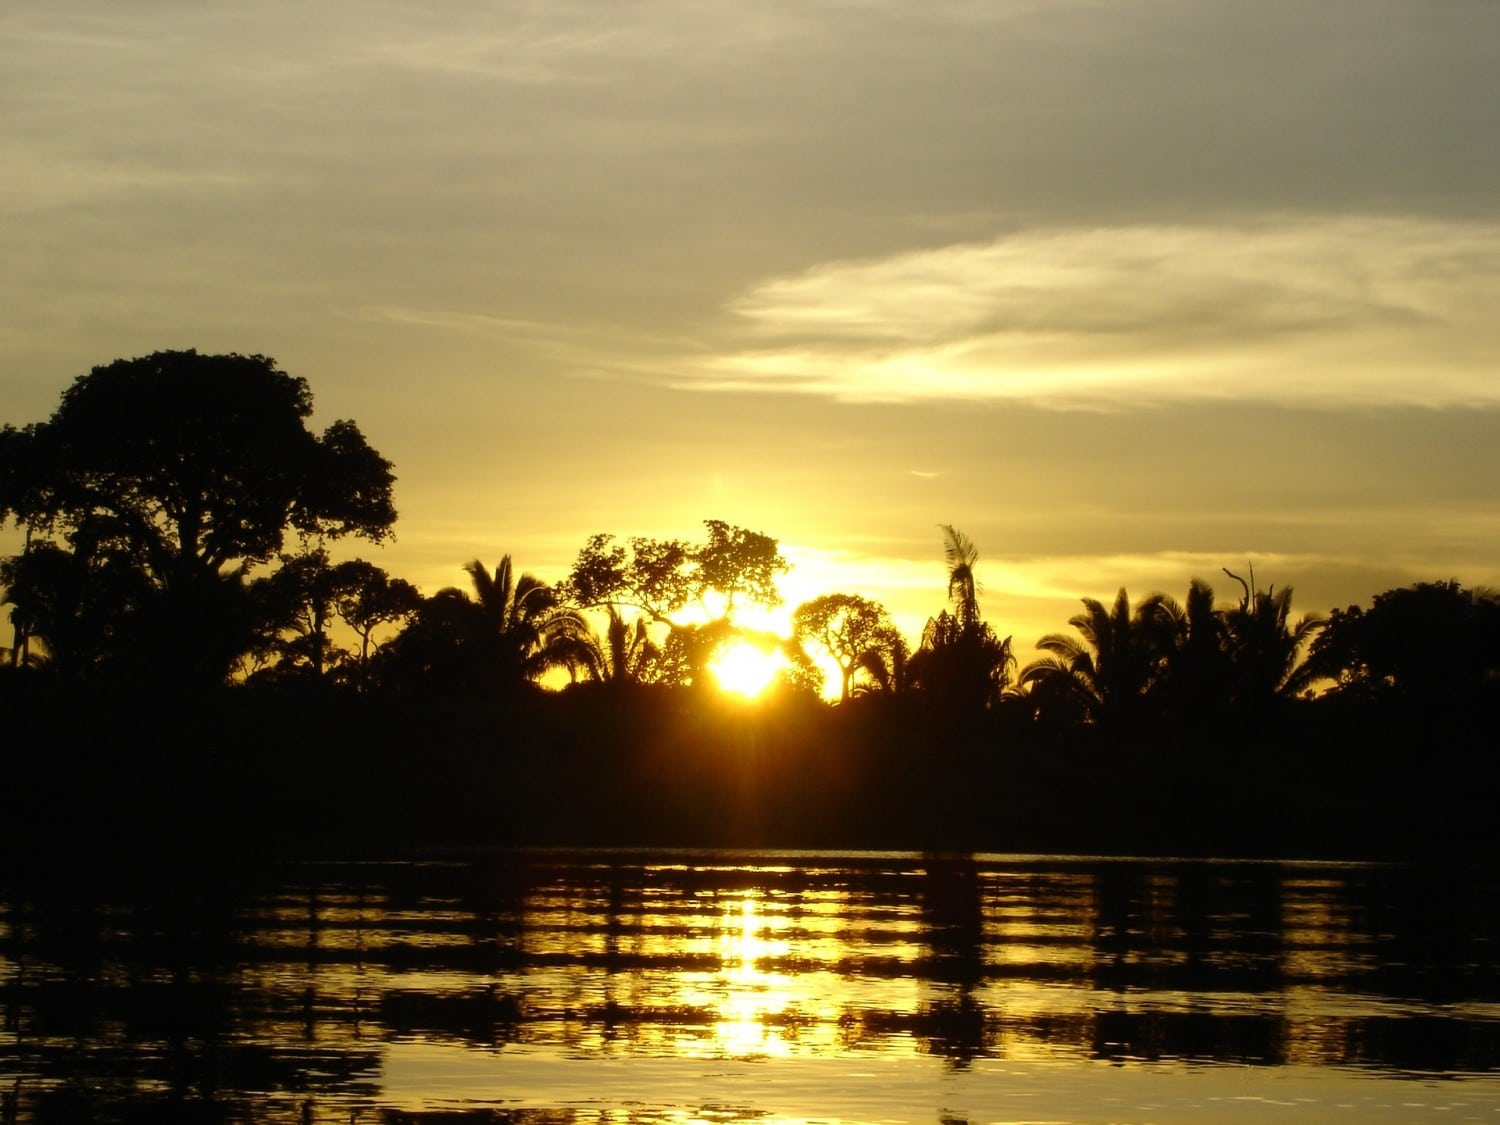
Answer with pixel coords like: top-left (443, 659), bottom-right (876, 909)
top-left (0, 852), bottom-right (1500, 1125)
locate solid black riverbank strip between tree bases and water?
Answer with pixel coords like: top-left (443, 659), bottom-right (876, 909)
top-left (0, 683), bottom-right (1500, 863)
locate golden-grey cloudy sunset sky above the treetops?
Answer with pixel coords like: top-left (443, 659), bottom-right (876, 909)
top-left (0, 0), bottom-right (1500, 656)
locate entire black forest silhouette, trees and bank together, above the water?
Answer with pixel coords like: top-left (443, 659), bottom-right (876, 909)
top-left (0, 351), bottom-right (1500, 857)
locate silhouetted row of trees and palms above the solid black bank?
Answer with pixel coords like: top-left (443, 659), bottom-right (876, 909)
top-left (0, 351), bottom-right (1500, 735)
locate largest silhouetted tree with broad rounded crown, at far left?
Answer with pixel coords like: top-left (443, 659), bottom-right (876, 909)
top-left (0, 351), bottom-right (396, 680)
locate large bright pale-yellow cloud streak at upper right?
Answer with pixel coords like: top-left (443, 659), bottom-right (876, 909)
top-left (680, 216), bottom-right (1500, 407)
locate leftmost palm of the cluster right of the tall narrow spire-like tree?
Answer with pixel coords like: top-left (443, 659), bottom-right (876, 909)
top-left (1020, 588), bottom-right (1172, 723)
